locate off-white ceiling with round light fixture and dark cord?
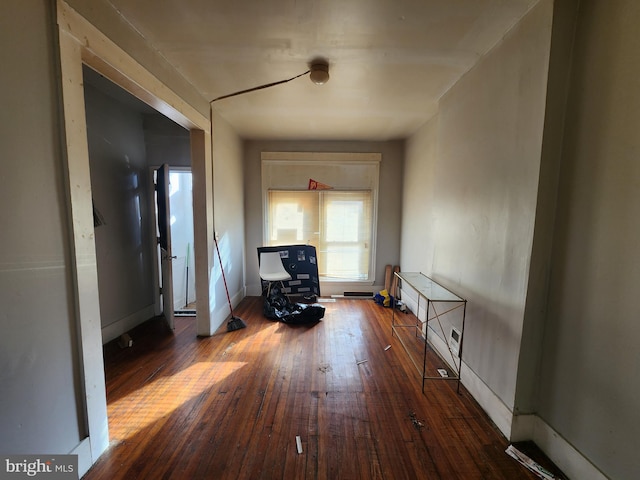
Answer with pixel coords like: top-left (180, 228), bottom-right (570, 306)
top-left (95, 0), bottom-right (538, 140)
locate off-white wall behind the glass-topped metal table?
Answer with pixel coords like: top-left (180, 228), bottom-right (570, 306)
top-left (401, 1), bottom-right (551, 411)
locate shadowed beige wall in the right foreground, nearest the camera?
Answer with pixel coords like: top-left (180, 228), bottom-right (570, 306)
top-left (539, 0), bottom-right (640, 479)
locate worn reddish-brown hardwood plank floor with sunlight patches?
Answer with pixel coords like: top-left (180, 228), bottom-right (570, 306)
top-left (84, 297), bottom-right (552, 480)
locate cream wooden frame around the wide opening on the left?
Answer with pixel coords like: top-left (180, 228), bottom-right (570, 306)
top-left (56, 0), bottom-right (213, 475)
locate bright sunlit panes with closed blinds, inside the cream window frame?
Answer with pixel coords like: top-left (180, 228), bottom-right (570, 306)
top-left (267, 190), bottom-right (372, 281)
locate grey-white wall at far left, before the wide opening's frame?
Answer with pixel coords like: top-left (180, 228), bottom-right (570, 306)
top-left (0, 1), bottom-right (86, 454)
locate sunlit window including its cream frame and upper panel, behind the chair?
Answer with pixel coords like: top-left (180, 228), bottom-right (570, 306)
top-left (261, 152), bottom-right (382, 282)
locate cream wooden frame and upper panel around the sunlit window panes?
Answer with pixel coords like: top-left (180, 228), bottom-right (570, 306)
top-left (261, 152), bottom-right (382, 286)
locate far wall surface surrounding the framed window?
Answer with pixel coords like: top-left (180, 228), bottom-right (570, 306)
top-left (244, 140), bottom-right (404, 295)
